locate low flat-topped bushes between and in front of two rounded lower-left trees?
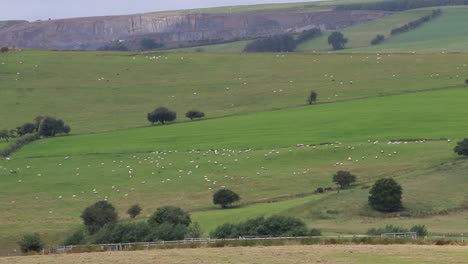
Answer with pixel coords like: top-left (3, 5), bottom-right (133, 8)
top-left (92, 222), bottom-right (152, 244)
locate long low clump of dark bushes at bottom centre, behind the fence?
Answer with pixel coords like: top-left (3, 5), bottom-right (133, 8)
top-left (211, 215), bottom-right (320, 238)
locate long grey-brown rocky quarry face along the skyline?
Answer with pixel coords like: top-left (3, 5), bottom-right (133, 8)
top-left (0, 11), bottom-right (391, 50)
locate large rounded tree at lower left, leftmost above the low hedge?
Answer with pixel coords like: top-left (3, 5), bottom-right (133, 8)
top-left (81, 201), bottom-right (118, 234)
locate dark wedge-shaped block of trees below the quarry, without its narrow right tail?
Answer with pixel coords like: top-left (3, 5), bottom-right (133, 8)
top-left (244, 34), bottom-right (296, 52)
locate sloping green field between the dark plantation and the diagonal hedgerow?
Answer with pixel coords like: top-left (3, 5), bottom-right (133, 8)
top-left (297, 9), bottom-right (432, 52)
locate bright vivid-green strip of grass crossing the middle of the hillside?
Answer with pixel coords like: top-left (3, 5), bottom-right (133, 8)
top-left (15, 87), bottom-right (468, 157)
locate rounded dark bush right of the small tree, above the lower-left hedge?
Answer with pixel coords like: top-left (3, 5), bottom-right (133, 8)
top-left (148, 206), bottom-right (192, 226)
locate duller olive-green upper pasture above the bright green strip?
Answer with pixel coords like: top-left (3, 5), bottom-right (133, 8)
top-left (0, 51), bottom-right (468, 133)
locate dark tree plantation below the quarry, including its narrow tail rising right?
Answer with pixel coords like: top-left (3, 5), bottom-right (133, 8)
top-left (244, 28), bottom-right (322, 52)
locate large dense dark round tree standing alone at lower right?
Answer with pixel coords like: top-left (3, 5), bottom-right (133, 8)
top-left (369, 178), bottom-right (403, 212)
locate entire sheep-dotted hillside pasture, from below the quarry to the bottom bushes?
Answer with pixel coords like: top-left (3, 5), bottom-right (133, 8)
top-left (0, 51), bottom-right (468, 253)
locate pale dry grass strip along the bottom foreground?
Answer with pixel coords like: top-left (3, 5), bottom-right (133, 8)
top-left (0, 245), bottom-right (468, 264)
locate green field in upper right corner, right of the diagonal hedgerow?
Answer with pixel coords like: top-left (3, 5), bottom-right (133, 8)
top-left (348, 7), bottom-right (468, 53)
